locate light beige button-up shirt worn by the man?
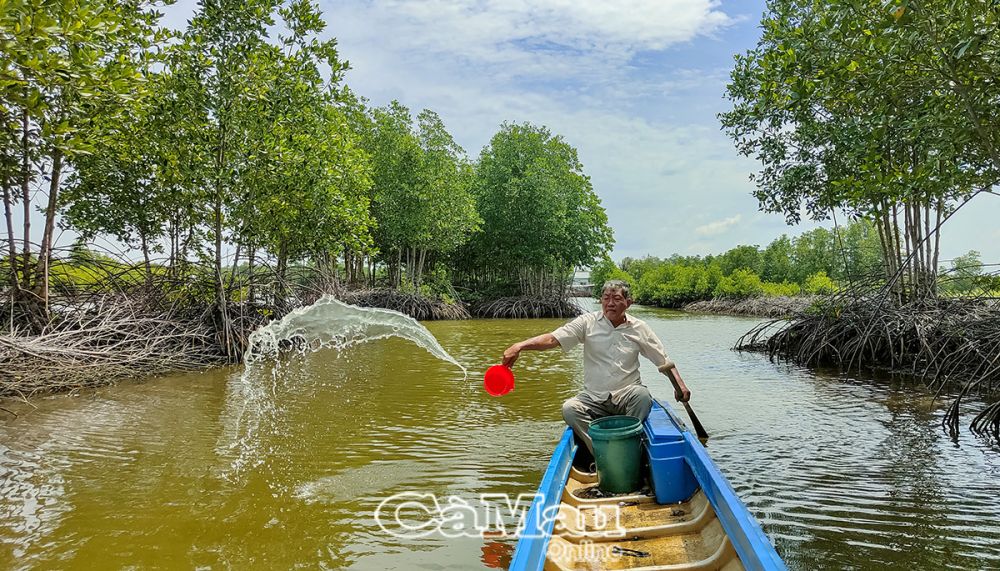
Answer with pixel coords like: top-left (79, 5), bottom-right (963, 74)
top-left (552, 311), bottom-right (673, 401)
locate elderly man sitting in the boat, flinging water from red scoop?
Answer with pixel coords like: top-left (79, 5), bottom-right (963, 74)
top-left (503, 280), bottom-right (691, 460)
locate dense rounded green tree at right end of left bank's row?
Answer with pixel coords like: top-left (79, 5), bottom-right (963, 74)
top-left (459, 123), bottom-right (612, 295)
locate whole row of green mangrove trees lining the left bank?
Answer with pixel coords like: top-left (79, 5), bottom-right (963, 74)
top-left (0, 0), bottom-right (617, 320)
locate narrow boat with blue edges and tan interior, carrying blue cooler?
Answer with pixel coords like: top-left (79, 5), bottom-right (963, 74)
top-left (510, 404), bottom-right (785, 571)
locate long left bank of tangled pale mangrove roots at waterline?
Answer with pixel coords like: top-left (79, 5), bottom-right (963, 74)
top-left (0, 287), bottom-right (582, 399)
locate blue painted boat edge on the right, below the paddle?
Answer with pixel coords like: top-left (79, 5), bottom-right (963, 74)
top-left (654, 405), bottom-right (787, 571)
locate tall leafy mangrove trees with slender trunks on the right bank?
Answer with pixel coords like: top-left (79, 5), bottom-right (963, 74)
top-left (720, 0), bottom-right (1000, 299)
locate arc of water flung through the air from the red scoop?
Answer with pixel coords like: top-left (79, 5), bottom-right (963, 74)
top-left (218, 296), bottom-right (468, 480)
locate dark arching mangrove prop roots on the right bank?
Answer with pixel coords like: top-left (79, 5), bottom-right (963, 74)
top-left (736, 291), bottom-right (1000, 441)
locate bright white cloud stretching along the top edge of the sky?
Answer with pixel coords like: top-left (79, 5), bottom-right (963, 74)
top-left (323, 0), bottom-right (733, 80)
